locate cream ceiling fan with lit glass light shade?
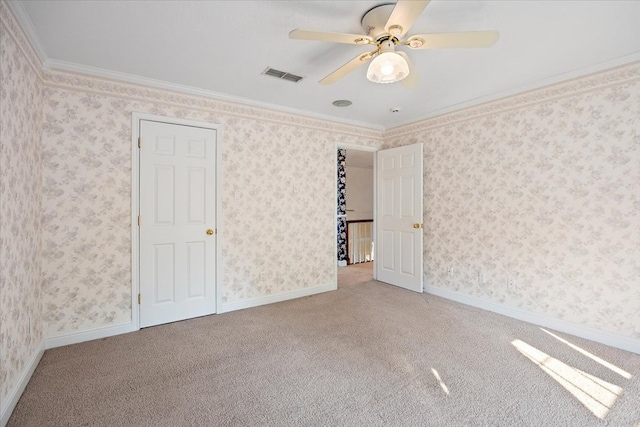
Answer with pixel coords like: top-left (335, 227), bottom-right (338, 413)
top-left (289, 0), bottom-right (499, 87)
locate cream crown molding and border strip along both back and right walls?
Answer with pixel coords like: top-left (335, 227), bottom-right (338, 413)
top-left (38, 53), bottom-right (640, 140)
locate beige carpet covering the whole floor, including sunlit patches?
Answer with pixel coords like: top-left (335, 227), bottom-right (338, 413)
top-left (9, 266), bottom-right (640, 427)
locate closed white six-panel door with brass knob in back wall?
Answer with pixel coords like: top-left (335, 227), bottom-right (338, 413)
top-left (139, 120), bottom-right (216, 327)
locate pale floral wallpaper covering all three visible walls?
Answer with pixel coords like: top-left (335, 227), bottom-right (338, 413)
top-left (0, 1), bottom-right (640, 403)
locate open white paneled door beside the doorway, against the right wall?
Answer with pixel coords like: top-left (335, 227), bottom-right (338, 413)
top-left (375, 143), bottom-right (423, 292)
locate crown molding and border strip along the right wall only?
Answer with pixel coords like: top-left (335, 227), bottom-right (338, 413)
top-left (384, 53), bottom-right (640, 140)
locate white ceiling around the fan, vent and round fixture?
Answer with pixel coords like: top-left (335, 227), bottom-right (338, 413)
top-left (11, 0), bottom-right (640, 129)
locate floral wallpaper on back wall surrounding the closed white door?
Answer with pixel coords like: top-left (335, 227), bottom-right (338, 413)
top-left (42, 72), bottom-right (382, 335)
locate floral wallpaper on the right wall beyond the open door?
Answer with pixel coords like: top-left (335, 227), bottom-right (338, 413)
top-left (385, 63), bottom-right (640, 339)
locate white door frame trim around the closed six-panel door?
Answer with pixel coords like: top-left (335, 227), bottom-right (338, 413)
top-left (131, 111), bottom-right (224, 331)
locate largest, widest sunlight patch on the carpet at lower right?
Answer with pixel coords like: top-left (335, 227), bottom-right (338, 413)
top-left (511, 340), bottom-right (622, 419)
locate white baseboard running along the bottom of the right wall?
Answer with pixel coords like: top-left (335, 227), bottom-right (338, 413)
top-left (424, 285), bottom-right (640, 354)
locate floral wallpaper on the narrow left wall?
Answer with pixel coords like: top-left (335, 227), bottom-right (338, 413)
top-left (0, 2), bottom-right (44, 408)
